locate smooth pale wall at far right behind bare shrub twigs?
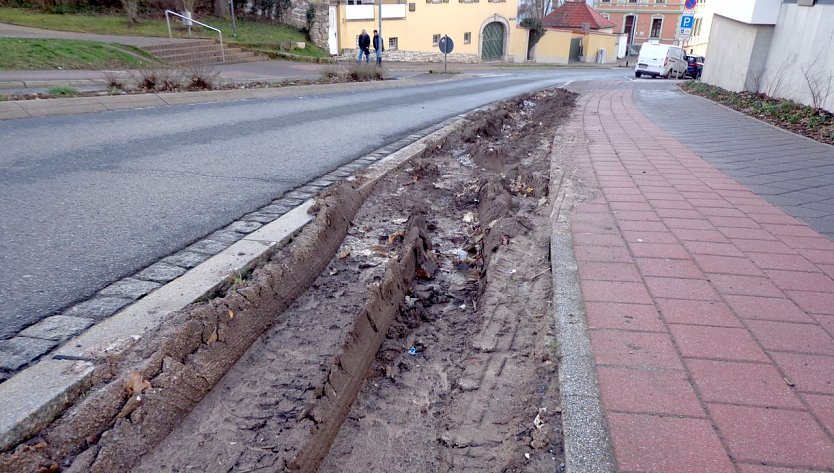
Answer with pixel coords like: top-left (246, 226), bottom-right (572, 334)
top-left (759, 3), bottom-right (834, 110)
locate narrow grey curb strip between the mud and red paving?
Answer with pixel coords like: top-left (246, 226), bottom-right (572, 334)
top-left (550, 119), bottom-right (617, 473)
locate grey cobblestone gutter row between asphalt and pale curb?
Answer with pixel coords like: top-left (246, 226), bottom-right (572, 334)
top-left (0, 118), bottom-right (454, 382)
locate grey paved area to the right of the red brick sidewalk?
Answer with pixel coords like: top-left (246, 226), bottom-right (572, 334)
top-left (635, 90), bottom-right (834, 238)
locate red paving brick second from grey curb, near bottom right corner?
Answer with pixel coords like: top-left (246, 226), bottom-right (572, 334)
top-left (709, 404), bottom-right (834, 468)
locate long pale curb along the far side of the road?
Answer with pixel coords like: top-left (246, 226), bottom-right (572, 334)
top-left (0, 74), bottom-right (469, 120)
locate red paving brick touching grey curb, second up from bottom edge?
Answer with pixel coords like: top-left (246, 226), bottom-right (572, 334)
top-left (597, 367), bottom-right (705, 417)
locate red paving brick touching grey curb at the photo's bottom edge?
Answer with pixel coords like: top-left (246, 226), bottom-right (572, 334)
top-left (608, 413), bottom-right (734, 473)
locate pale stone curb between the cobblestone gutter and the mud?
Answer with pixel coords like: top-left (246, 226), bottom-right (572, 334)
top-left (0, 109), bottom-right (462, 451)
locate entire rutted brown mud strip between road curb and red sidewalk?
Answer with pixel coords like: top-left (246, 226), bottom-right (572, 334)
top-left (0, 89), bottom-right (575, 473)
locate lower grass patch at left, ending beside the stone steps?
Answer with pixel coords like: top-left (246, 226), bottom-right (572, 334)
top-left (0, 38), bottom-right (157, 70)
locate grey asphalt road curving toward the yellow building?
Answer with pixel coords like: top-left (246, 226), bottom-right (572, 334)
top-left (0, 69), bottom-right (629, 339)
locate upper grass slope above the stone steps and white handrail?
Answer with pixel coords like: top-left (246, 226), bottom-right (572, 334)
top-left (0, 8), bottom-right (327, 57)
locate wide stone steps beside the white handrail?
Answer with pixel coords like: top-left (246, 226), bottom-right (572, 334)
top-left (142, 39), bottom-right (267, 65)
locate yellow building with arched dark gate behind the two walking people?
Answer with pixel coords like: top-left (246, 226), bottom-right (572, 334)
top-left (330, 0), bottom-right (527, 62)
